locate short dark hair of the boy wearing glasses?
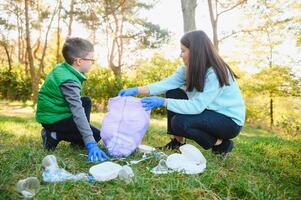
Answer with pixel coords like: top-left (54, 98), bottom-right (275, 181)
top-left (62, 37), bottom-right (94, 65)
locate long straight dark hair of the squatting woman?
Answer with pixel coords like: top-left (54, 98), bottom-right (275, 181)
top-left (181, 31), bottom-right (237, 92)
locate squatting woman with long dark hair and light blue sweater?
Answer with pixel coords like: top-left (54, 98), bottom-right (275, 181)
top-left (119, 31), bottom-right (245, 154)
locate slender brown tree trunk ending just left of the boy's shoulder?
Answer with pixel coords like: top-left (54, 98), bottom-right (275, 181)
top-left (24, 0), bottom-right (39, 105)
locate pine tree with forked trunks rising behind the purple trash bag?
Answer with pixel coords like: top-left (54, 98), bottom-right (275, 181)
top-left (77, 0), bottom-right (169, 77)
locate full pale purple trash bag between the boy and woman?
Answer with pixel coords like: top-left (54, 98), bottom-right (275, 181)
top-left (101, 96), bottom-right (150, 157)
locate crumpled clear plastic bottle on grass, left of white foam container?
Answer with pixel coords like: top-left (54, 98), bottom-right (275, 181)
top-left (42, 155), bottom-right (89, 183)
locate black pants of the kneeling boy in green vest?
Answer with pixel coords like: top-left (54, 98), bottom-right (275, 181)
top-left (42, 97), bottom-right (101, 146)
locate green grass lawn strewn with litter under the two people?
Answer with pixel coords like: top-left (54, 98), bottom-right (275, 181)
top-left (0, 102), bottom-right (301, 199)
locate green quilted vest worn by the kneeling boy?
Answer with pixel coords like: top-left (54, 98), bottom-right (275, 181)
top-left (36, 63), bottom-right (86, 124)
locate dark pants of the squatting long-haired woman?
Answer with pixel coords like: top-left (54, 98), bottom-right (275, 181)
top-left (166, 89), bottom-right (241, 149)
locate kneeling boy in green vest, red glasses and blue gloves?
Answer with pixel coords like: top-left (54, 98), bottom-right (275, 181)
top-left (36, 38), bottom-right (109, 161)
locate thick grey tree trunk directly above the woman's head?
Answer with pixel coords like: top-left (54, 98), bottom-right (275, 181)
top-left (181, 0), bottom-right (197, 33)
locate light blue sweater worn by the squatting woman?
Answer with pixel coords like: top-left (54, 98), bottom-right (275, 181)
top-left (148, 66), bottom-right (245, 126)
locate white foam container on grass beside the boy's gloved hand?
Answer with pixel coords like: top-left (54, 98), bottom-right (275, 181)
top-left (89, 161), bottom-right (122, 181)
